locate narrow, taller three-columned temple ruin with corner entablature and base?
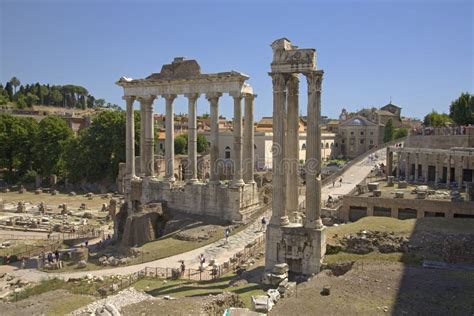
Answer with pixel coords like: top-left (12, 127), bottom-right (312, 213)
top-left (265, 38), bottom-right (326, 275)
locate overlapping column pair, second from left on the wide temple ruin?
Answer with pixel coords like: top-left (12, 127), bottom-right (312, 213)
top-left (139, 95), bottom-right (155, 177)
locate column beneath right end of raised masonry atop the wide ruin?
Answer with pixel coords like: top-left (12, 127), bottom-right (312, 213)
top-left (184, 93), bottom-right (199, 183)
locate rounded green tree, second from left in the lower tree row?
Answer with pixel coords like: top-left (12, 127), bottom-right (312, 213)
top-left (34, 116), bottom-right (73, 176)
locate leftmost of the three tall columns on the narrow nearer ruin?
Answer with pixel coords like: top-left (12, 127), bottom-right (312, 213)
top-left (270, 73), bottom-right (289, 225)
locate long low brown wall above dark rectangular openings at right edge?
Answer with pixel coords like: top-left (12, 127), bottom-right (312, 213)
top-left (340, 195), bottom-right (474, 221)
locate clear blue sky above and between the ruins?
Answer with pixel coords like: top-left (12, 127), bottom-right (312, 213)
top-left (0, 0), bottom-right (474, 118)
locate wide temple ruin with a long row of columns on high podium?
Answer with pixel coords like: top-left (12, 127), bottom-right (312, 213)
top-left (116, 57), bottom-right (259, 230)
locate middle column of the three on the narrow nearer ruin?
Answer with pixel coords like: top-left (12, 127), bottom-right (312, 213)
top-left (285, 74), bottom-right (299, 220)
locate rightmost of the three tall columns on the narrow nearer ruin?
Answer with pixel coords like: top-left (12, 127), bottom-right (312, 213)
top-left (305, 70), bottom-right (323, 229)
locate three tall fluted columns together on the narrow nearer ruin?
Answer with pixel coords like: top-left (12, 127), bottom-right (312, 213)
top-left (270, 71), bottom-right (323, 229)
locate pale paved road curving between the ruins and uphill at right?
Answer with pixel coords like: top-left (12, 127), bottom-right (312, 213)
top-left (0, 149), bottom-right (385, 281)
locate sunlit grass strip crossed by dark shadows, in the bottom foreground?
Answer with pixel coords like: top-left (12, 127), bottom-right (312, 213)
top-left (133, 274), bottom-right (265, 308)
